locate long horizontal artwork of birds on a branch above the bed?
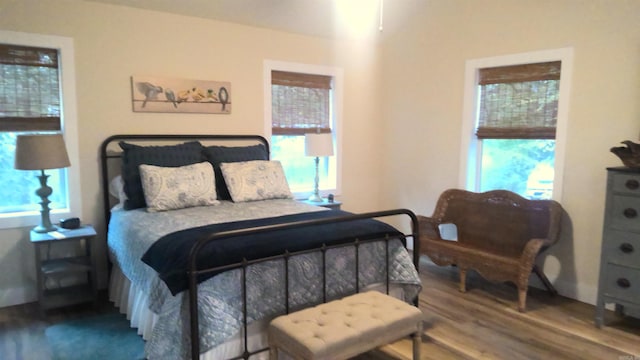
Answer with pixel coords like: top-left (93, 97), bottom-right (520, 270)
top-left (131, 76), bottom-right (231, 114)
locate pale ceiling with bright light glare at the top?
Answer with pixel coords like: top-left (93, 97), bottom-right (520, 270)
top-left (85, 0), bottom-right (426, 40)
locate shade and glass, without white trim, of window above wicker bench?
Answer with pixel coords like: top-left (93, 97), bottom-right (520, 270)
top-left (475, 61), bottom-right (561, 199)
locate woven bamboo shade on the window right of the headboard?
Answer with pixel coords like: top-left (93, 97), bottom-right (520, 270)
top-left (271, 71), bottom-right (331, 135)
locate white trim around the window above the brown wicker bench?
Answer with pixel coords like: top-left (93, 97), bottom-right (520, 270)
top-left (458, 47), bottom-right (573, 201)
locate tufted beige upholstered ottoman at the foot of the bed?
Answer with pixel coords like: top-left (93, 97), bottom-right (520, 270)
top-left (269, 291), bottom-right (423, 360)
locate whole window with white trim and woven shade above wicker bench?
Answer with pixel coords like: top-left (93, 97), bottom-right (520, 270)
top-left (462, 50), bottom-right (571, 199)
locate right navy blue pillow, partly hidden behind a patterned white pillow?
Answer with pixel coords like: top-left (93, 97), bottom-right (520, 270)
top-left (203, 144), bottom-right (269, 200)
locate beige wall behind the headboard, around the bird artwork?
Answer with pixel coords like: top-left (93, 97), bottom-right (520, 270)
top-left (0, 0), bottom-right (382, 306)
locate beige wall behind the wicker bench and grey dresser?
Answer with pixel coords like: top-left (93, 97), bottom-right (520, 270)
top-left (382, 0), bottom-right (640, 303)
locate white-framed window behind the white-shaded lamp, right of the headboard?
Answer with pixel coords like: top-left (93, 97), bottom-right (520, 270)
top-left (265, 62), bottom-right (339, 198)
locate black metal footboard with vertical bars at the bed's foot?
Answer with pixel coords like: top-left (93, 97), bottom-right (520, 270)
top-left (187, 209), bottom-right (420, 360)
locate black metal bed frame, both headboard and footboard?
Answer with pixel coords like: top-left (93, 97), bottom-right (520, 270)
top-left (100, 134), bottom-right (420, 360)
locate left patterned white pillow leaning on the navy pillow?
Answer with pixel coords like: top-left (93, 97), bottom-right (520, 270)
top-left (140, 162), bottom-right (220, 212)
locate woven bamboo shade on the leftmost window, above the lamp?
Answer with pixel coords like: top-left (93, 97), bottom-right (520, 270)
top-left (0, 44), bottom-right (61, 132)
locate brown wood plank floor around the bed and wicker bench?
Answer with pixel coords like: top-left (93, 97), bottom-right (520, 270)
top-left (0, 255), bottom-right (640, 360)
